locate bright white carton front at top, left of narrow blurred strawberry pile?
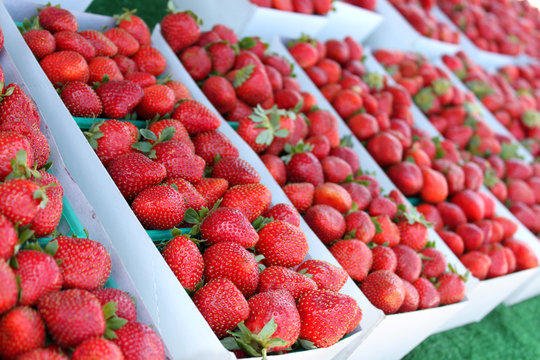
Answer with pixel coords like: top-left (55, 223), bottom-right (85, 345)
top-left (316, 1), bottom-right (383, 42)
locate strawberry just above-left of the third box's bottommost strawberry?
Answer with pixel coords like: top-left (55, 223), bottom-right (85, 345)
top-left (330, 239), bottom-right (373, 282)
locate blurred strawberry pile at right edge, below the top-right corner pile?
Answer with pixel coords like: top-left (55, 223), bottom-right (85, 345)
top-left (442, 51), bottom-right (540, 156)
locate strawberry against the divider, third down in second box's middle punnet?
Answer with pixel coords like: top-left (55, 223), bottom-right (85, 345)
top-left (212, 157), bottom-right (261, 186)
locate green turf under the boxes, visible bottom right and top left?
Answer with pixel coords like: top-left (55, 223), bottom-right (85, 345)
top-left (83, 0), bottom-right (540, 360)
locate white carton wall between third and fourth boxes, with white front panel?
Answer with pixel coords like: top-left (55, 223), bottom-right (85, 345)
top-left (269, 38), bottom-right (478, 359)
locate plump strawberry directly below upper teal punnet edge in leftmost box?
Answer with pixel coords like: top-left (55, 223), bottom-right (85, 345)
top-left (54, 236), bottom-right (111, 290)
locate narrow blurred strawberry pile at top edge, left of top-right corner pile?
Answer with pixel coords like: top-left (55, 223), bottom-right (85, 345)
top-left (390, 0), bottom-right (459, 44)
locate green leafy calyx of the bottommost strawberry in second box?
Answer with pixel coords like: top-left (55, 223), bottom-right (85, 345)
top-left (221, 317), bottom-right (288, 360)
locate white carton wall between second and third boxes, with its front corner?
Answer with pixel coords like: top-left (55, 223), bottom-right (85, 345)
top-left (152, 24), bottom-right (384, 360)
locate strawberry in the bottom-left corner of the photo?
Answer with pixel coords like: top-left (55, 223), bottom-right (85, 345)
top-left (0, 306), bottom-right (45, 359)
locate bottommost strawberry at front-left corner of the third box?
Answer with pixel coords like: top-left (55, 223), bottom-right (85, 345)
top-left (361, 270), bottom-right (405, 314)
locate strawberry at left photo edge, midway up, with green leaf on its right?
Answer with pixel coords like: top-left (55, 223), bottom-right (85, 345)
top-left (0, 179), bottom-right (47, 226)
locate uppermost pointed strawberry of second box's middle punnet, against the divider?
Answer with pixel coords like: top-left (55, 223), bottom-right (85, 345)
top-left (172, 100), bottom-right (220, 135)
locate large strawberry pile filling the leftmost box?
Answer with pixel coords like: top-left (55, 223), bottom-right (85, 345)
top-left (0, 30), bottom-right (165, 359)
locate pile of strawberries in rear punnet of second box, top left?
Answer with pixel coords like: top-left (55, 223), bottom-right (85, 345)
top-left (23, 6), bottom-right (187, 119)
